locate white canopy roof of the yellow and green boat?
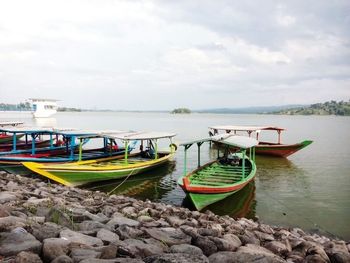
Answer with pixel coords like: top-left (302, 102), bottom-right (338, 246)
top-left (101, 132), bottom-right (176, 141)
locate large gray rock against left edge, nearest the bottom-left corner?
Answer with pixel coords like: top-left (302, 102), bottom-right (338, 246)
top-left (0, 228), bottom-right (41, 256)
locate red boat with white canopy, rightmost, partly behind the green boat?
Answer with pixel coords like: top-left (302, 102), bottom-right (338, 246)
top-left (209, 125), bottom-right (312, 157)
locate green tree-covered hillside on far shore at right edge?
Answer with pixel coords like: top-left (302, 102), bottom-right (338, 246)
top-left (273, 100), bottom-right (350, 116)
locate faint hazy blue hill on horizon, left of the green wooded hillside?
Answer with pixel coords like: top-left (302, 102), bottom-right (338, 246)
top-left (196, 105), bottom-right (306, 114)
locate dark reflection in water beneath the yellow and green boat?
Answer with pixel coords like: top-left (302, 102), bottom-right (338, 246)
top-left (85, 161), bottom-right (176, 200)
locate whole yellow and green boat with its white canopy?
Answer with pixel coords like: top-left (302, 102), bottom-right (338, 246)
top-left (23, 132), bottom-right (176, 186)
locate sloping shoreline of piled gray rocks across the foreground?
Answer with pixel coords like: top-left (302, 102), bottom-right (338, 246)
top-left (0, 172), bottom-right (350, 263)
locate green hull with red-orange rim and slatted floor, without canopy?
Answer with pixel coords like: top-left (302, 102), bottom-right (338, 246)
top-left (178, 156), bottom-right (256, 211)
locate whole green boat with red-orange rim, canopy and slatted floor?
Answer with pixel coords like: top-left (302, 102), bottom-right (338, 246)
top-left (178, 135), bottom-right (258, 211)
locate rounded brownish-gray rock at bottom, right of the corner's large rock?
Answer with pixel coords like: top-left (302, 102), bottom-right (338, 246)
top-left (42, 238), bottom-right (71, 262)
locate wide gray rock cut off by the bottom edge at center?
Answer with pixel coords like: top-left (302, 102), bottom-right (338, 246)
top-left (144, 253), bottom-right (209, 263)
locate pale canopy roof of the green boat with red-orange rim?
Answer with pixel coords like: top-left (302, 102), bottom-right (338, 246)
top-left (180, 134), bottom-right (259, 149)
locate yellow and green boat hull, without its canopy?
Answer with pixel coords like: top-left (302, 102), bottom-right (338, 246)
top-left (23, 153), bottom-right (173, 186)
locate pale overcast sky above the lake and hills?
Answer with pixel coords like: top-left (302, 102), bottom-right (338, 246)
top-left (0, 0), bottom-right (350, 110)
